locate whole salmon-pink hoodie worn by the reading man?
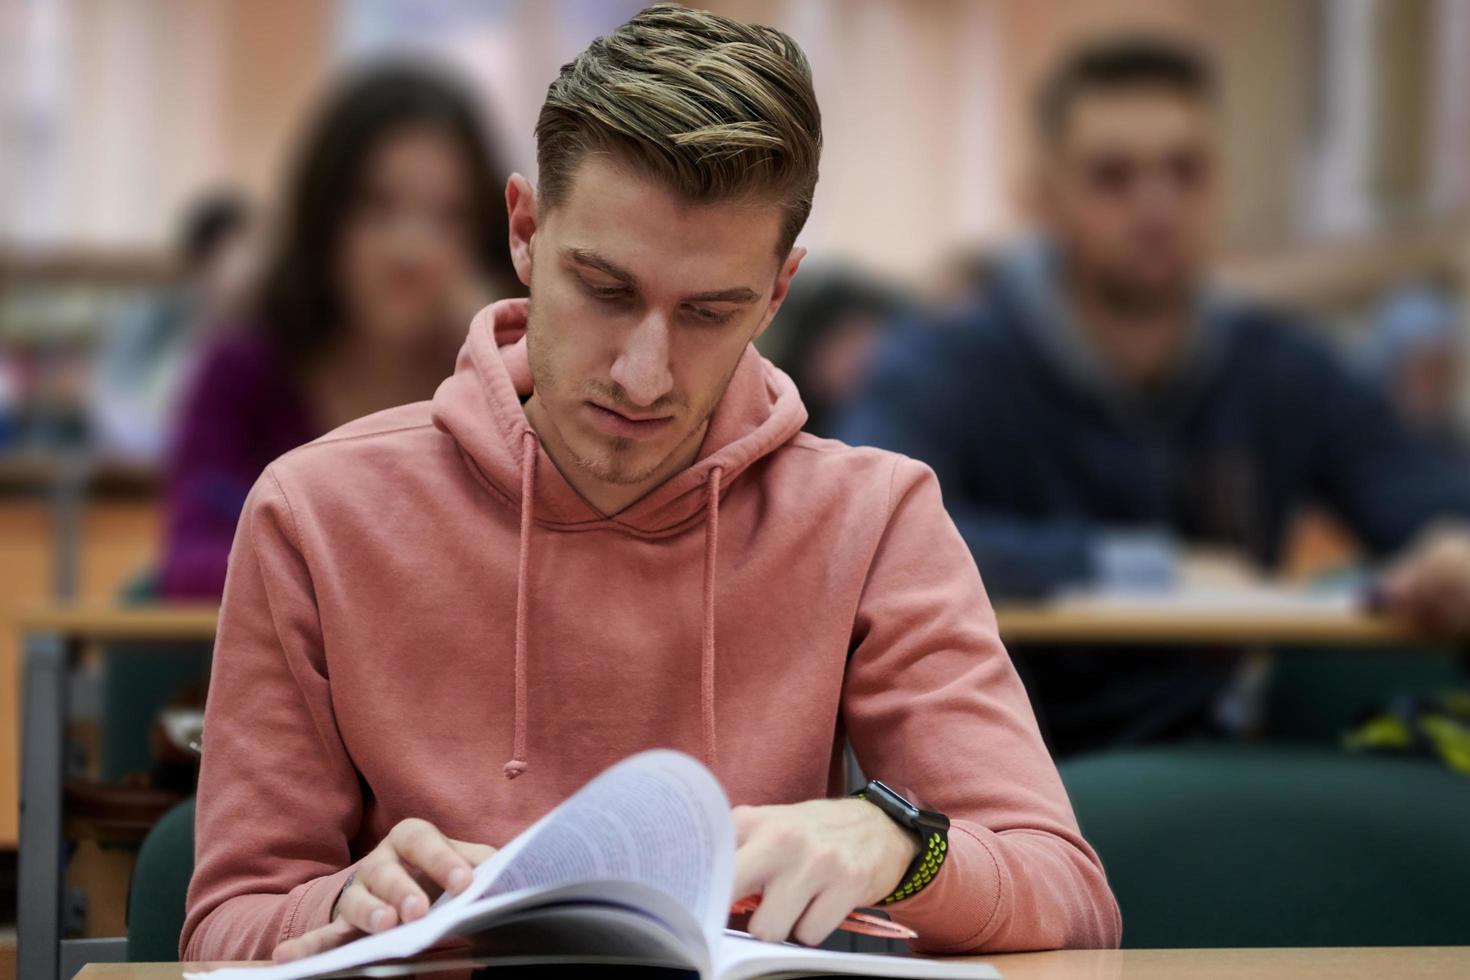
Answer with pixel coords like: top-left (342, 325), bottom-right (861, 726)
top-left (181, 300), bottom-right (1120, 959)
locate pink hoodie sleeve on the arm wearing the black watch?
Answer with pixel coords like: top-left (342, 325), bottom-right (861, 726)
top-left (842, 457), bottom-right (1122, 954)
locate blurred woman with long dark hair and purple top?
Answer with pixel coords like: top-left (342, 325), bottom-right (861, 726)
top-left (159, 65), bottom-right (519, 598)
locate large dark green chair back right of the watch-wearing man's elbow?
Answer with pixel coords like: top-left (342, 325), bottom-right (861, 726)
top-left (1061, 745), bottom-right (1470, 948)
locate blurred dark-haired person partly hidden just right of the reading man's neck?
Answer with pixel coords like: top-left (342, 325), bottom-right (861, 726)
top-left (757, 262), bottom-right (908, 436)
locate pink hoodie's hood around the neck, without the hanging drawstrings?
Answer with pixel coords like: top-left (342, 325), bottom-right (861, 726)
top-left (434, 300), bottom-right (807, 535)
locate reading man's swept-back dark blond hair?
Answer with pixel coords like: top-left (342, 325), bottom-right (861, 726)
top-left (537, 3), bottom-right (822, 256)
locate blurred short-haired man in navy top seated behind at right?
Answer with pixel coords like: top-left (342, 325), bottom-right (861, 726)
top-left (838, 35), bottom-right (1470, 752)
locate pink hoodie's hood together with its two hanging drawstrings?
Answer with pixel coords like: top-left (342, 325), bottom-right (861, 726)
top-left (434, 300), bottom-right (807, 779)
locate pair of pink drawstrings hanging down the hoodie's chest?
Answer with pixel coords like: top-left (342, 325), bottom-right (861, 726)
top-left (504, 443), bottom-right (725, 779)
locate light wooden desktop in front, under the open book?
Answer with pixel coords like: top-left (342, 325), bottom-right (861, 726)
top-left (76, 946), bottom-right (1470, 980)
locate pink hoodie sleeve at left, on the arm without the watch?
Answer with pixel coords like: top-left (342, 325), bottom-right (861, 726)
top-left (179, 469), bottom-right (363, 959)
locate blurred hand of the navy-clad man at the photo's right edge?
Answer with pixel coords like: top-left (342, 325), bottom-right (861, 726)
top-left (1379, 525), bottom-right (1470, 639)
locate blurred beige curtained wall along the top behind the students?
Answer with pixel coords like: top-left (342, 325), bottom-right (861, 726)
top-left (0, 0), bottom-right (1470, 278)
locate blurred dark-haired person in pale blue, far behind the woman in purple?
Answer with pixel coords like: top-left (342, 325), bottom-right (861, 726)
top-left (90, 191), bottom-right (257, 461)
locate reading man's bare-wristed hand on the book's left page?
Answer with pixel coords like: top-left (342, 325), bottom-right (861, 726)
top-left (273, 818), bottom-right (495, 962)
